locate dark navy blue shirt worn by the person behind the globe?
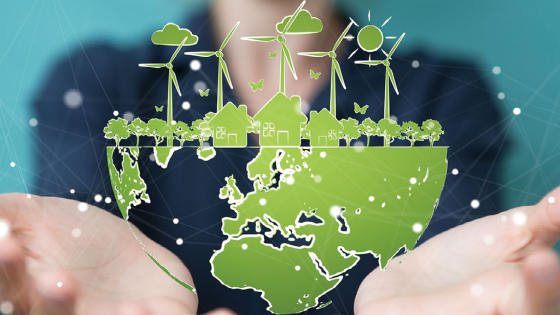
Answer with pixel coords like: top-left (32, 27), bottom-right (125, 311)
top-left (34, 11), bottom-right (506, 314)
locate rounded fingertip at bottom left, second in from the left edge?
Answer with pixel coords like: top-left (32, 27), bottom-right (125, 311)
top-left (32, 272), bottom-right (77, 315)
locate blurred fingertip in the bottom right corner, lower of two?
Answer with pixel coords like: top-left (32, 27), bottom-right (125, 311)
top-left (523, 250), bottom-right (560, 315)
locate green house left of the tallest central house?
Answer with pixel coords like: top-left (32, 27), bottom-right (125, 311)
top-left (208, 102), bottom-right (251, 148)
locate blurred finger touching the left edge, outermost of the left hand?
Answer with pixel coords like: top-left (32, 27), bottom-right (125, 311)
top-left (0, 228), bottom-right (31, 314)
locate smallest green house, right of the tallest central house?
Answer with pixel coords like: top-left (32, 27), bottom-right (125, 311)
top-left (306, 108), bottom-right (343, 147)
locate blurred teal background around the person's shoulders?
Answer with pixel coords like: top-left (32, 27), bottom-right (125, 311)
top-left (0, 0), bottom-right (560, 230)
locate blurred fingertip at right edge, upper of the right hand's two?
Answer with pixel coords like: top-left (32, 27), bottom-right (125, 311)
top-left (528, 187), bottom-right (560, 247)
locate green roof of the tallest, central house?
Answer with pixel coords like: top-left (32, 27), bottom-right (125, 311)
top-left (255, 93), bottom-right (307, 123)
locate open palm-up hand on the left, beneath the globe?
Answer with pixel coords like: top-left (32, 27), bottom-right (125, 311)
top-left (0, 194), bottom-right (201, 315)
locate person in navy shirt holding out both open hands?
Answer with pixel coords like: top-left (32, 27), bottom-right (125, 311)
top-left (0, 0), bottom-right (540, 314)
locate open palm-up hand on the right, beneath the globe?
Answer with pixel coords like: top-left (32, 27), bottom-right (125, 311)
top-left (354, 189), bottom-right (560, 315)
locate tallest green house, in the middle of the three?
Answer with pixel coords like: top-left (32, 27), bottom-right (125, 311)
top-left (254, 93), bottom-right (307, 147)
